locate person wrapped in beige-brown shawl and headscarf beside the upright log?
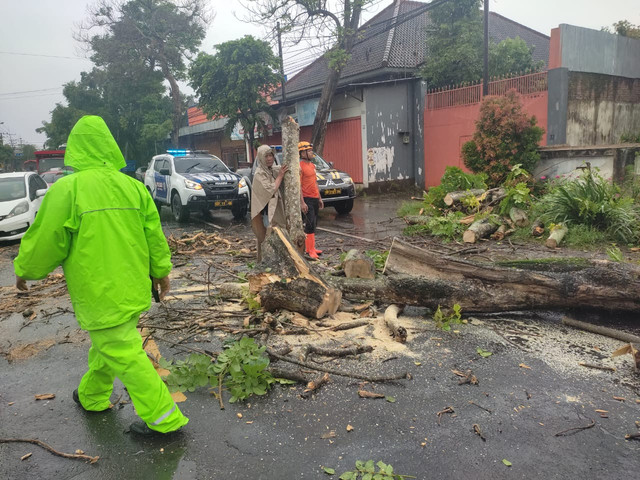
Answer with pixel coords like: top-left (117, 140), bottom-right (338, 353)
top-left (251, 145), bottom-right (289, 262)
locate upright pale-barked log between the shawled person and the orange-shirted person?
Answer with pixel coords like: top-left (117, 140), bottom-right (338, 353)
top-left (282, 117), bottom-right (305, 252)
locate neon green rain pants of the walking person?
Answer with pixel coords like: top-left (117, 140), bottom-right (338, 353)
top-left (78, 315), bottom-right (189, 433)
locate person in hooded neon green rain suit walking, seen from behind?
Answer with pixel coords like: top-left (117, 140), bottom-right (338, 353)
top-left (14, 116), bottom-right (189, 435)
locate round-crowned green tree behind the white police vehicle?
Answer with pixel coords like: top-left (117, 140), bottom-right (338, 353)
top-left (189, 35), bottom-right (280, 161)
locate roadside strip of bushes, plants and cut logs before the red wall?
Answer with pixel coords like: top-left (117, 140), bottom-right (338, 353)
top-left (398, 91), bottom-right (640, 253)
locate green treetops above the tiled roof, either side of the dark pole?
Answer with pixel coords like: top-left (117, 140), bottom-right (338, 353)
top-left (420, 0), bottom-right (544, 88)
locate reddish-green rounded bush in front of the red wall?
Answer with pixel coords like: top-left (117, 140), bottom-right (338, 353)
top-left (462, 90), bottom-right (544, 186)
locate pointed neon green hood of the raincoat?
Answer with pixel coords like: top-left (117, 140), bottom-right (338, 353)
top-left (64, 115), bottom-right (126, 172)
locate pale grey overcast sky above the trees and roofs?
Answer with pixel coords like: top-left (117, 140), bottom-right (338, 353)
top-left (0, 0), bottom-right (640, 147)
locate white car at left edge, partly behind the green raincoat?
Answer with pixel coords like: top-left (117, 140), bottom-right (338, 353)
top-left (0, 172), bottom-right (48, 241)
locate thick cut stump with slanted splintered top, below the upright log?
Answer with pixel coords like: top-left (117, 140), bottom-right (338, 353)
top-left (248, 227), bottom-right (342, 319)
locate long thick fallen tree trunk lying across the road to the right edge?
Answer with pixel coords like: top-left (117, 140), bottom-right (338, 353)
top-left (328, 238), bottom-right (640, 312)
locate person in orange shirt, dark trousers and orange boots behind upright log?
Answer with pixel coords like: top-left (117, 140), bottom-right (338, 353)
top-left (298, 142), bottom-right (324, 259)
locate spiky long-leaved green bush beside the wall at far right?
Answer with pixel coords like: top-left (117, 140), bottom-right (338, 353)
top-left (541, 168), bottom-right (640, 243)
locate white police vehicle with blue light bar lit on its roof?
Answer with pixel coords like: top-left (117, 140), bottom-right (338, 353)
top-left (144, 150), bottom-right (249, 222)
